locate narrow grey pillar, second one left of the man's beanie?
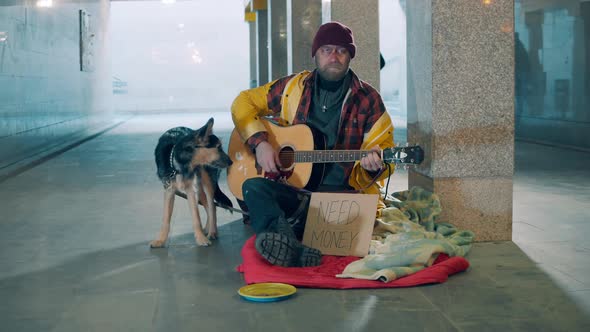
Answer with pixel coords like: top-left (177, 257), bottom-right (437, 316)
top-left (267, 0), bottom-right (288, 82)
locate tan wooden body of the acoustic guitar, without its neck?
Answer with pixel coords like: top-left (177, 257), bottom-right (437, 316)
top-left (227, 121), bottom-right (314, 200)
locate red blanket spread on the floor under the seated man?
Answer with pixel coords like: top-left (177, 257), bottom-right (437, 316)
top-left (237, 236), bottom-right (469, 289)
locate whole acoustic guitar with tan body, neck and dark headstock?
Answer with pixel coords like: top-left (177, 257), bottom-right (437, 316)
top-left (227, 120), bottom-right (424, 200)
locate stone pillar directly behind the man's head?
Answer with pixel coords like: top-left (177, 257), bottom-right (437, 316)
top-left (322, 0), bottom-right (380, 90)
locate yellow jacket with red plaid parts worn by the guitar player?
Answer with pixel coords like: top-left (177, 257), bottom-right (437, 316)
top-left (231, 71), bottom-right (395, 210)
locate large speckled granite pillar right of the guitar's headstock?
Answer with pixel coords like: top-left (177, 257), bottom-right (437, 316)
top-left (406, 0), bottom-right (514, 241)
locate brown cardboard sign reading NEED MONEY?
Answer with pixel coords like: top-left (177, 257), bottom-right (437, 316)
top-left (303, 193), bottom-right (379, 257)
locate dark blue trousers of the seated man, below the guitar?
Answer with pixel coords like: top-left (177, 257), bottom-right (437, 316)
top-left (242, 178), bottom-right (309, 239)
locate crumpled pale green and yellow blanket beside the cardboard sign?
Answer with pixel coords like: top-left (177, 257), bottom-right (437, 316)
top-left (337, 187), bottom-right (474, 282)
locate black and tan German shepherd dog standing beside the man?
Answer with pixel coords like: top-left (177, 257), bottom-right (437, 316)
top-left (150, 118), bottom-right (233, 248)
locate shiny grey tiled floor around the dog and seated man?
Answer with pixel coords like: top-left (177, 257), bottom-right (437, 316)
top-left (0, 114), bottom-right (590, 332)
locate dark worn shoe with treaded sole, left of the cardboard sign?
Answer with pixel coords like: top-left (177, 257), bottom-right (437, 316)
top-left (256, 232), bottom-right (322, 267)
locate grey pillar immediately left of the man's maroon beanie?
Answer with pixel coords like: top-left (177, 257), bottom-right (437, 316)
top-left (287, 0), bottom-right (322, 74)
